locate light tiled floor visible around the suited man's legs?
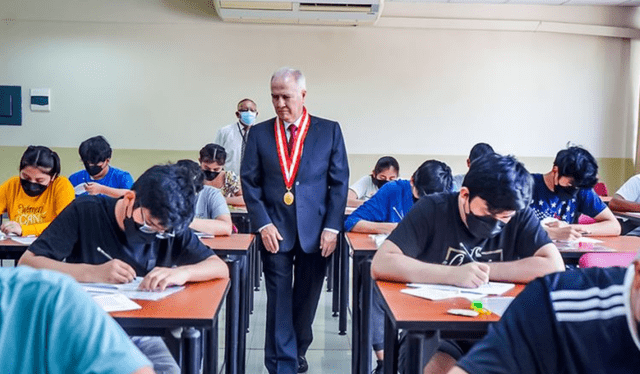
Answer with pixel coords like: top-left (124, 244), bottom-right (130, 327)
top-left (220, 276), bottom-right (351, 374)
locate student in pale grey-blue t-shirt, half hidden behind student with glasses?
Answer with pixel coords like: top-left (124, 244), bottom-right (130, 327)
top-left (176, 160), bottom-right (233, 236)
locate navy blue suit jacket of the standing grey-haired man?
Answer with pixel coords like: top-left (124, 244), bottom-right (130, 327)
top-left (241, 116), bottom-right (349, 253)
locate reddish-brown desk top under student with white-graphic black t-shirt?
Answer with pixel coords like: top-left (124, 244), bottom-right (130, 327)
top-left (376, 281), bottom-right (524, 331)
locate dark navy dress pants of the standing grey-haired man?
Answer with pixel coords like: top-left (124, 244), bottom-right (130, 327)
top-left (261, 239), bottom-right (327, 374)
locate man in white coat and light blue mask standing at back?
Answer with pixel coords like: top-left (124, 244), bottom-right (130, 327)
top-left (214, 99), bottom-right (258, 175)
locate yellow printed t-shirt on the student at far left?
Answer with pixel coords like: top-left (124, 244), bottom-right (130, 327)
top-left (0, 176), bottom-right (75, 236)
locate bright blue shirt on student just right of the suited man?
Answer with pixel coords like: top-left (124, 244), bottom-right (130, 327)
top-left (344, 180), bottom-right (413, 231)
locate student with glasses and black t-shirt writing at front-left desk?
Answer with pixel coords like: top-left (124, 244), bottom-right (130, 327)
top-left (19, 165), bottom-right (229, 373)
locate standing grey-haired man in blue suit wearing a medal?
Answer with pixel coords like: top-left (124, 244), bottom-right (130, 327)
top-left (241, 68), bottom-right (349, 374)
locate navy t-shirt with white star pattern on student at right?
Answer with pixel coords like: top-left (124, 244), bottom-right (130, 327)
top-left (531, 174), bottom-right (607, 223)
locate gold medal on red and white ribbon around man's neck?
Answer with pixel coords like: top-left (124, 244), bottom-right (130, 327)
top-left (275, 108), bottom-right (310, 205)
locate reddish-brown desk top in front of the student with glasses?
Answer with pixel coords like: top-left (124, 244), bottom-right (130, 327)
top-left (110, 278), bottom-right (229, 325)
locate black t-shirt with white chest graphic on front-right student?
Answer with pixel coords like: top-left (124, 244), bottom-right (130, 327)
top-left (389, 193), bottom-right (551, 265)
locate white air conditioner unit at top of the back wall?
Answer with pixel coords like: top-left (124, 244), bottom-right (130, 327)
top-left (214, 0), bottom-right (384, 26)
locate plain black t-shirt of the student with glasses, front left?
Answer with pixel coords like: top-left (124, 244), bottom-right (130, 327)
top-left (29, 196), bottom-right (214, 276)
